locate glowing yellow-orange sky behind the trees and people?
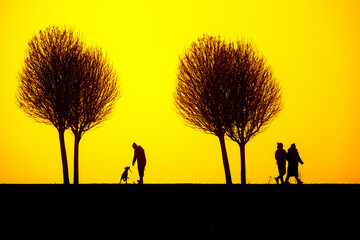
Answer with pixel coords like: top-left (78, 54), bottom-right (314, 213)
top-left (0, 0), bottom-right (360, 183)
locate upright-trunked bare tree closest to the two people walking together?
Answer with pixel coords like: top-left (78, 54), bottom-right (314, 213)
top-left (227, 41), bottom-right (282, 184)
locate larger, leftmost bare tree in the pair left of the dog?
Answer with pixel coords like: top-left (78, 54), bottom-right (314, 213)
top-left (16, 26), bottom-right (84, 184)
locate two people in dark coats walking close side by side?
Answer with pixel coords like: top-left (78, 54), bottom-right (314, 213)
top-left (275, 143), bottom-right (304, 184)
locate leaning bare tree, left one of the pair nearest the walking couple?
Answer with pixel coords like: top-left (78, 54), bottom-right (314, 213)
top-left (174, 35), bottom-right (234, 184)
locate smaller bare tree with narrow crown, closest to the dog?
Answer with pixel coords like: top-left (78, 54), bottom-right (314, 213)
top-left (70, 48), bottom-right (119, 184)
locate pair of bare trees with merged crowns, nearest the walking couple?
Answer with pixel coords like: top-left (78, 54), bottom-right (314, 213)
top-left (174, 35), bottom-right (282, 184)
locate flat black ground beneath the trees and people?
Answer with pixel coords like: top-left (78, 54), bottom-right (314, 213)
top-left (0, 184), bottom-right (360, 236)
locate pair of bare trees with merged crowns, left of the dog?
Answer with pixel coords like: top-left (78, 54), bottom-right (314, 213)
top-left (16, 26), bottom-right (118, 184)
